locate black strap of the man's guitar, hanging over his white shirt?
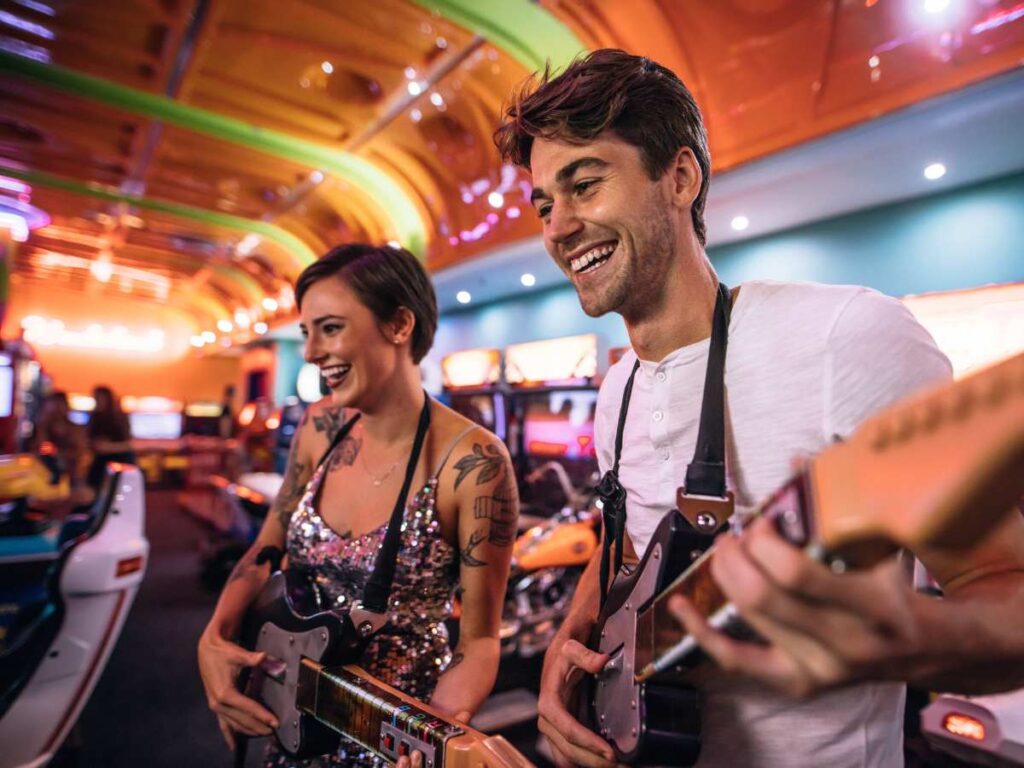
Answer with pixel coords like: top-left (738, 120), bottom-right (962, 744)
top-left (597, 283), bottom-right (731, 607)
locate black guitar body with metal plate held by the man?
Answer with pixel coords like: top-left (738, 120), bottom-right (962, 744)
top-left (584, 510), bottom-right (707, 766)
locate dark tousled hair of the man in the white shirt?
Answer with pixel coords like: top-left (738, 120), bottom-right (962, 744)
top-left (495, 48), bottom-right (711, 245)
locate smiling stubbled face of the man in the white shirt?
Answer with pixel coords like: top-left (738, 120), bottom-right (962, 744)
top-left (530, 131), bottom-right (677, 319)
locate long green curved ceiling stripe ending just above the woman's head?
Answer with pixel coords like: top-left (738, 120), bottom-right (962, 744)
top-left (0, 51), bottom-right (427, 256)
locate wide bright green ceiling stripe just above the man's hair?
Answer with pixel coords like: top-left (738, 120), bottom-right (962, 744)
top-left (405, 0), bottom-right (587, 72)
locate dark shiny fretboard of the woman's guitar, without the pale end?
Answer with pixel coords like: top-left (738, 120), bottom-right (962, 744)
top-left (297, 659), bottom-right (465, 768)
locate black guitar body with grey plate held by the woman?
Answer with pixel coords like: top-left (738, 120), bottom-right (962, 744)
top-left (240, 570), bottom-right (366, 760)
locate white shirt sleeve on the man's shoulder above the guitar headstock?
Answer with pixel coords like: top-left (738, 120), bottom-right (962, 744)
top-left (823, 289), bottom-right (952, 439)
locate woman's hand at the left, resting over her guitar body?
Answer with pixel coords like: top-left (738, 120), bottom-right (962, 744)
top-left (193, 628), bottom-right (279, 751)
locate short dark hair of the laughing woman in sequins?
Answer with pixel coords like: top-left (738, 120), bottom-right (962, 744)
top-left (295, 243), bottom-right (437, 364)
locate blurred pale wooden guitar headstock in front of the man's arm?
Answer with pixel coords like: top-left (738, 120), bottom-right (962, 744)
top-left (808, 354), bottom-right (1024, 564)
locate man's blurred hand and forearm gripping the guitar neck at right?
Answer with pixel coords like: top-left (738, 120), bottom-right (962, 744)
top-left (670, 519), bottom-right (1024, 697)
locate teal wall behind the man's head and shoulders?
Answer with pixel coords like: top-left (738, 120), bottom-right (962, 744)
top-left (430, 174), bottom-right (1024, 364)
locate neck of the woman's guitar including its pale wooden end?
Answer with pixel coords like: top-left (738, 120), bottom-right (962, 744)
top-left (296, 658), bottom-right (534, 768)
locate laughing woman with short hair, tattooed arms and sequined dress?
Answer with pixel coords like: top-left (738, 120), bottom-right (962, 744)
top-left (199, 245), bottom-right (518, 766)
